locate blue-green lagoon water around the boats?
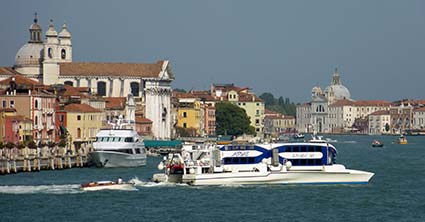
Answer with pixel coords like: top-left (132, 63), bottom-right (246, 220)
top-left (0, 136), bottom-right (425, 222)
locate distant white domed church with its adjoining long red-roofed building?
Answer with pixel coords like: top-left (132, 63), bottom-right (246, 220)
top-left (297, 69), bottom-right (391, 133)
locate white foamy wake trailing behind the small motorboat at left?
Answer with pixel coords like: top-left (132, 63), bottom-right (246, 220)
top-left (0, 184), bottom-right (82, 194)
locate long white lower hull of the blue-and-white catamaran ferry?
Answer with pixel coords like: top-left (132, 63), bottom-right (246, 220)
top-left (182, 166), bottom-right (374, 185)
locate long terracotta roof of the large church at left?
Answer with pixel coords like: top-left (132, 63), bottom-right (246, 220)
top-left (59, 61), bottom-right (165, 78)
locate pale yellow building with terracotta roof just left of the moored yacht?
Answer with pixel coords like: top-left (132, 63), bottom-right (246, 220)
top-left (64, 104), bottom-right (103, 149)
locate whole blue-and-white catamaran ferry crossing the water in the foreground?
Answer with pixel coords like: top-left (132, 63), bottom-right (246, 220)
top-left (153, 139), bottom-right (374, 185)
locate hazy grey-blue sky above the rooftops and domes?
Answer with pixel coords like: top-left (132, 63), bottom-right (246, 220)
top-left (0, 0), bottom-right (425, 102)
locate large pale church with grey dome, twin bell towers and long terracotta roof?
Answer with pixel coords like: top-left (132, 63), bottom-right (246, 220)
top-left (0, 15), bottom-right (174, 139)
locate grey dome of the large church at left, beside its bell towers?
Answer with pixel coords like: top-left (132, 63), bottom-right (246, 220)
top-left (15, 42), bottom-right (44, 66)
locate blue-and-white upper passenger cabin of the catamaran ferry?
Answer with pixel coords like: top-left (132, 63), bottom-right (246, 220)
top-left (219, 143), bottom-right (337, 166)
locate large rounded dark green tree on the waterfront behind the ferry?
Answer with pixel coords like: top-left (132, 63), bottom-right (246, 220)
top-left (215, 102), bottom-right (255, 136)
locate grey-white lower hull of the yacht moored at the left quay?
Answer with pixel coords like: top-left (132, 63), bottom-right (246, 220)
top-left (91, 151), bottom-right (146, 167)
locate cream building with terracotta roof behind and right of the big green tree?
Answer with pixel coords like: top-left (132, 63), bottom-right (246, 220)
top-left (210, 84), bottom-right (265, 137)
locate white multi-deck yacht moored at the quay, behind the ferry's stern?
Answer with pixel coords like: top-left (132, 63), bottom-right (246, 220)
top-left (90, 119), bottom-right (146, 167)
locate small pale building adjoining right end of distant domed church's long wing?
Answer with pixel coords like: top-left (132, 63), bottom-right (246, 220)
top-left (368, 110), bottom-right (391, 135)
